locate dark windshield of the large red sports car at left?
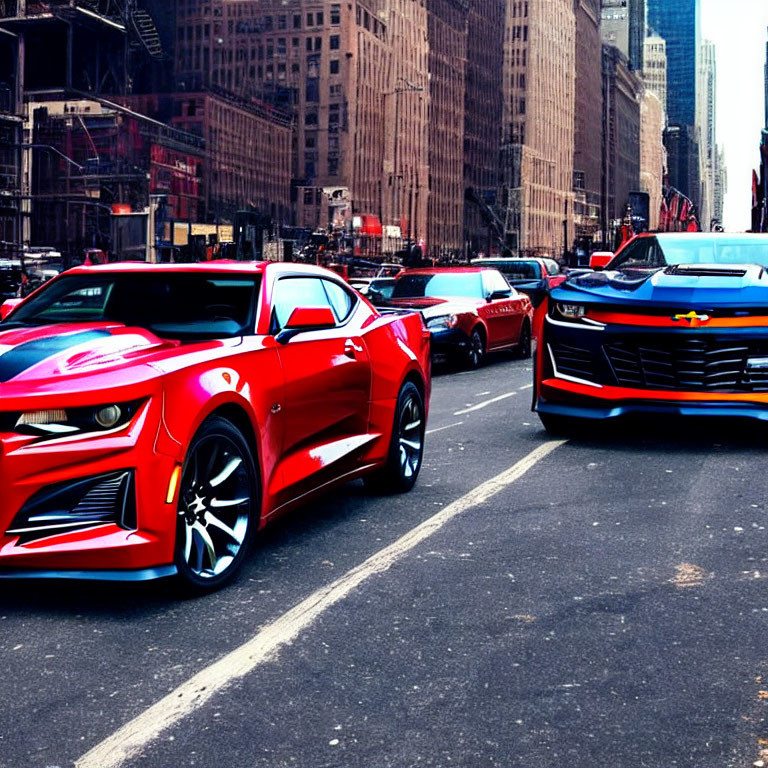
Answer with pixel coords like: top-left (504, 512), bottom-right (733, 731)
top-left (0, 272), bottom-right (260, 339)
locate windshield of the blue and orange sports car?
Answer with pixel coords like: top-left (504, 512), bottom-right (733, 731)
top-left (610, 235), bottom-right (768, 269)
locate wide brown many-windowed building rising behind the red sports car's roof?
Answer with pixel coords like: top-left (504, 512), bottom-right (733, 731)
top-left (172, 0), bottom-right (429, 250)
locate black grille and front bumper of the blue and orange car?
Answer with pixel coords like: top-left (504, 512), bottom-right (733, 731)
top-left (534, 310), bottom-right (768, 421)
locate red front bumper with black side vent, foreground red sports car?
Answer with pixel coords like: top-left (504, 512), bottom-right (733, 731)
top-left (0, 397), bottom-right (177, 581)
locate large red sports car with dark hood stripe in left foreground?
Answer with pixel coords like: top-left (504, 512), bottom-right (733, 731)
top-left (0, 262), bottom-right (430, 589)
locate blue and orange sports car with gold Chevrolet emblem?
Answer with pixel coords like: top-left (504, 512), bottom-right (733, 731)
top-left (534, 233), bottom-right (768, 432)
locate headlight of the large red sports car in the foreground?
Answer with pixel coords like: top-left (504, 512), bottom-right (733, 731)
top-left (13, 401), bottom-right (141, 437)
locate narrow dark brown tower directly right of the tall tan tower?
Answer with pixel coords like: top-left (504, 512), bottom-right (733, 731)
top-left (573, 0), bottom-right (603, 253)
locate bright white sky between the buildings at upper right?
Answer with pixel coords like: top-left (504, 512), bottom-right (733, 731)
top-left (701, 0), bottom-right (768, 231)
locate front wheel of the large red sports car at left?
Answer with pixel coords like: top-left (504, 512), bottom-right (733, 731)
top-left (174, 416), bottom-right (261, 593)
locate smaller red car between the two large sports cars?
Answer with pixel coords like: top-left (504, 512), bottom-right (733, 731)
top-left (386, 267), bottom-right (533, 368)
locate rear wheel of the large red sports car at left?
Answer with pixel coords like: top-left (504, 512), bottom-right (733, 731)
top-left (365, 381), bottom-right (426, 493)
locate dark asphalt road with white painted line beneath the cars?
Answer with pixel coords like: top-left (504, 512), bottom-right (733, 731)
top-left (0, 356), bottom-right (768, 768)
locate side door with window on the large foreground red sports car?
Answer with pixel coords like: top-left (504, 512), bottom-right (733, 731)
top-left (271, 275), bottom-right (371, 503)
